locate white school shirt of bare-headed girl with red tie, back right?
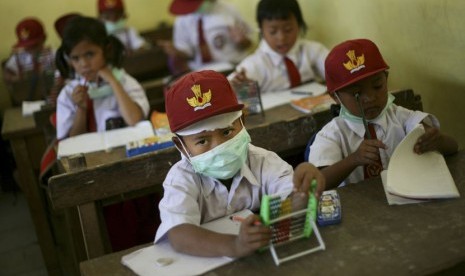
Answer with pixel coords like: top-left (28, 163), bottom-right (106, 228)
top-left (228, 39), bottom-right (328, 93)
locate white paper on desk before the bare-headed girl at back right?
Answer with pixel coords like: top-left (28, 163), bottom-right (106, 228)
top-left (260, 82), bottom-right (326, 110)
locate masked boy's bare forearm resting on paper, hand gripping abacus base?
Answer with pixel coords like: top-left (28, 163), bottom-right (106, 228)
top-left (168, 215), bottom-right (271, 258)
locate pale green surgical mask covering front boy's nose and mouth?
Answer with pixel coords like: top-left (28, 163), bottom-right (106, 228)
top-left (189, 127), bottom-right (251, 179)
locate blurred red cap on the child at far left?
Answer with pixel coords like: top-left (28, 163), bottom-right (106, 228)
top-left (13, 17), bottom-right (47, 48)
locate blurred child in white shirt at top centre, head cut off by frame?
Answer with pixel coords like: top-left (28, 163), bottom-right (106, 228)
top-left (158, 0), bottom-right (252, 75)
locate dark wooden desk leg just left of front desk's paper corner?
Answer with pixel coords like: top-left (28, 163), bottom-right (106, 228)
top-left (78, 202), bottom-right (107, 259)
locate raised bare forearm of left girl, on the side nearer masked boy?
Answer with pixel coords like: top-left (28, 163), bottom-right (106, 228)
top-left (99, 66), bottom-right (144, 126)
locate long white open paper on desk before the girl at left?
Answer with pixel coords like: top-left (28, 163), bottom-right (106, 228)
top-left (57, 121), bottom-right (155, 158)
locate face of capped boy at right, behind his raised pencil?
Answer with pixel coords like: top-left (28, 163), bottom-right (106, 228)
top-left (333, 71), bottom-right (388, 120)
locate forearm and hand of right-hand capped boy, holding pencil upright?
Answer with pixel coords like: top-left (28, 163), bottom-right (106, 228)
top-left (321, 139), bottom-right (386, 189)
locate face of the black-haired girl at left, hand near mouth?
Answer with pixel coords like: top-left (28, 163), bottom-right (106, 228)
top-left (69, 40), bottom-right (106, 81)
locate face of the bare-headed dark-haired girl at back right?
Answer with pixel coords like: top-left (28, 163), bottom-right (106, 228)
top-left (260, 15), bottom-right (300, 55)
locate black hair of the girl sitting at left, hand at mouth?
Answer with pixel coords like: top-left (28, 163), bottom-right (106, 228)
top-left (55, 16), bottom-right (125, 78)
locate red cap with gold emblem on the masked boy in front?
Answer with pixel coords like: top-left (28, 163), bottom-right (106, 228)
top-left (165, 70), bottom-right (244, 133)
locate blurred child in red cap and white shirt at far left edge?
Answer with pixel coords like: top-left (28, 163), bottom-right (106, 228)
top-left (3, 17), bottom-right (55, 105)
